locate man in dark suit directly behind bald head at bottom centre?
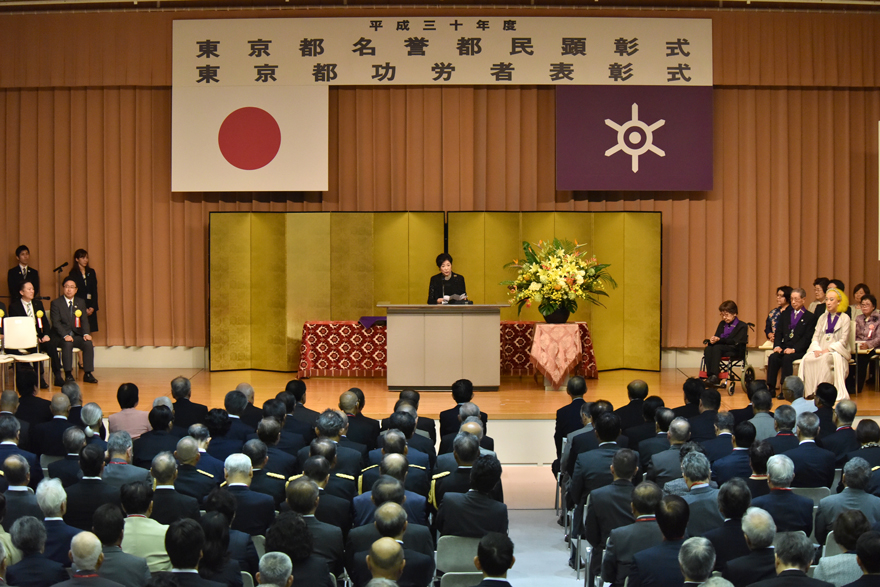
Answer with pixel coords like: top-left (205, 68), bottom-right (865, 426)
top-left (348, 502), bottom-right (434, 586)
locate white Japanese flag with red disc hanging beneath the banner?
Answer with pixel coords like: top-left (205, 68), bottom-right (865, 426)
top-left (171, 86), bottom-right (329, 192)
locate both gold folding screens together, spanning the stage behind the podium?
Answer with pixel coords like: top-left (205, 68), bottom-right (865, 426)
top-left (210, 212), bottom-right (661, 371)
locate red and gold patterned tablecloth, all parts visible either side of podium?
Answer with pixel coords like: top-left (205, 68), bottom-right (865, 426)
top-left (297, 321), bottom-right (599, 379)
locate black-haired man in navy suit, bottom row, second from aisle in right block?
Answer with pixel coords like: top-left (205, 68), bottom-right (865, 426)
top-left (629, 495), bottom-right (690, 587)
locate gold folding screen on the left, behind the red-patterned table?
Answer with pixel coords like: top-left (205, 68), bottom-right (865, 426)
top-left (209, 212), bottom-right (443, 371)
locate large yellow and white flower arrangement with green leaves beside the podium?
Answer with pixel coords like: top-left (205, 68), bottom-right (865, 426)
top-left (501, 238), bottom-right (617, 316)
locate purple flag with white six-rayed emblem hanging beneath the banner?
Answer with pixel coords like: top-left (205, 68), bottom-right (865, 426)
top-left (556, 86), bottom-right (712, 191)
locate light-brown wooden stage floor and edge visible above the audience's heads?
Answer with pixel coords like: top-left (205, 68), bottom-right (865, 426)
top-left (34, 367), bottom-right (880, 420)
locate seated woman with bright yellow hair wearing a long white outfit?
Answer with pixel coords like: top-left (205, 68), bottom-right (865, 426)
top-left (798, 287), bottom-right (851, 401)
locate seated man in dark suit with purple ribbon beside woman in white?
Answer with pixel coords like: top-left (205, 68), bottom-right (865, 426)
top-left (767, 287), bottom-right (816, 399)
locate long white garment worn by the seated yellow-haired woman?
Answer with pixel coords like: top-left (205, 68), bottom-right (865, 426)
top-left (798, 312), bottom-right (851, 401)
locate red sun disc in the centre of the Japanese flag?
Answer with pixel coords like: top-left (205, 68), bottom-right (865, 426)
top-left (217, 106), bottom-right (281, 171)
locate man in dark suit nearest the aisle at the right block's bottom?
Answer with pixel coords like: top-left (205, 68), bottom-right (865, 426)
top-left (602, 481), bottom-right (663, 587)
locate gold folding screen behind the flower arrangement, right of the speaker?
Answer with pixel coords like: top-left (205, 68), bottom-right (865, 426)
top-left (448, 212), bottom-right (661, 370)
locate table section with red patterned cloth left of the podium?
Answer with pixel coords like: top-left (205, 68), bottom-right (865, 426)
top-left (297, 320), bottom-right (387, 378)
